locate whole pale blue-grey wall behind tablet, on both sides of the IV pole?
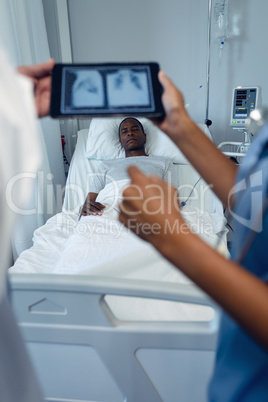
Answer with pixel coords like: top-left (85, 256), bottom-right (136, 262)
top-left (65, 0), bottom-right (268, 143)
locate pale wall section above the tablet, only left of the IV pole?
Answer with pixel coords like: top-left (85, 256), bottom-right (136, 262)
top-left (68, 0), bottom-right (208, 122)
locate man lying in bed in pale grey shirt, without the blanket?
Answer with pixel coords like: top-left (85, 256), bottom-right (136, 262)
top-left (81, 118), bottom-right (175, 220)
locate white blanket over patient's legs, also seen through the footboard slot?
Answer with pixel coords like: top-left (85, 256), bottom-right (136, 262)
top-left (10, 183), bottom-right (226, 321)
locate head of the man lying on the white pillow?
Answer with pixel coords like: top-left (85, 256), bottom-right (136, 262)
top-left (120, 119), bottom-right (146, 151)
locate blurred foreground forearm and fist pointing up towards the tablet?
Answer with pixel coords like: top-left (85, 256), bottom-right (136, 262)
top-left (119, 166), bottom-right (268, 350)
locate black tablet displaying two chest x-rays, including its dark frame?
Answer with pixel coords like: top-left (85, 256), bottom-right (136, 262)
top-left (50, 63), bottom-right (164, 118)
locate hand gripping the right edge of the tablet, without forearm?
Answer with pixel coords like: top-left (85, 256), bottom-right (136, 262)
top-left (153, 71), bottom-right (194, 142)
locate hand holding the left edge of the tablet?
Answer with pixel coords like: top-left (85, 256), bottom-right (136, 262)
top-left (17, 59), bottom-right (55, 117)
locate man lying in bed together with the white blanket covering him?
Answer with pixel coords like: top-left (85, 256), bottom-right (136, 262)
top-left (10, 118), bottom-right (226, 283)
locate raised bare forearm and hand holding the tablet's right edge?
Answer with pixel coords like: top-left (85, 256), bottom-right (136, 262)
top-left (158, 71), bottom-right (237, 205)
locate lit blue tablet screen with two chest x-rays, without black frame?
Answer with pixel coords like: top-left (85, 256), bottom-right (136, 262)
top-left (60, 65), bottom-right (155, 115)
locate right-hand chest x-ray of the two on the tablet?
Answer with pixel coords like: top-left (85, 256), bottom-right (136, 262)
top-left (107, 69), bottom-right (154, 108)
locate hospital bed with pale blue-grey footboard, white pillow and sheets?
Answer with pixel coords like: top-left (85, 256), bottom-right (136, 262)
top-left (10, 119), bottom-right (226, 402)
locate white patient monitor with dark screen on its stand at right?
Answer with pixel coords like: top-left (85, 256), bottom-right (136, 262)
top-left (218, 86), bottom-right (262, 158)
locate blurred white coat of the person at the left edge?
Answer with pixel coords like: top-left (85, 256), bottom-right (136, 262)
top-left (0, 48), bottom-right (43, 402)
